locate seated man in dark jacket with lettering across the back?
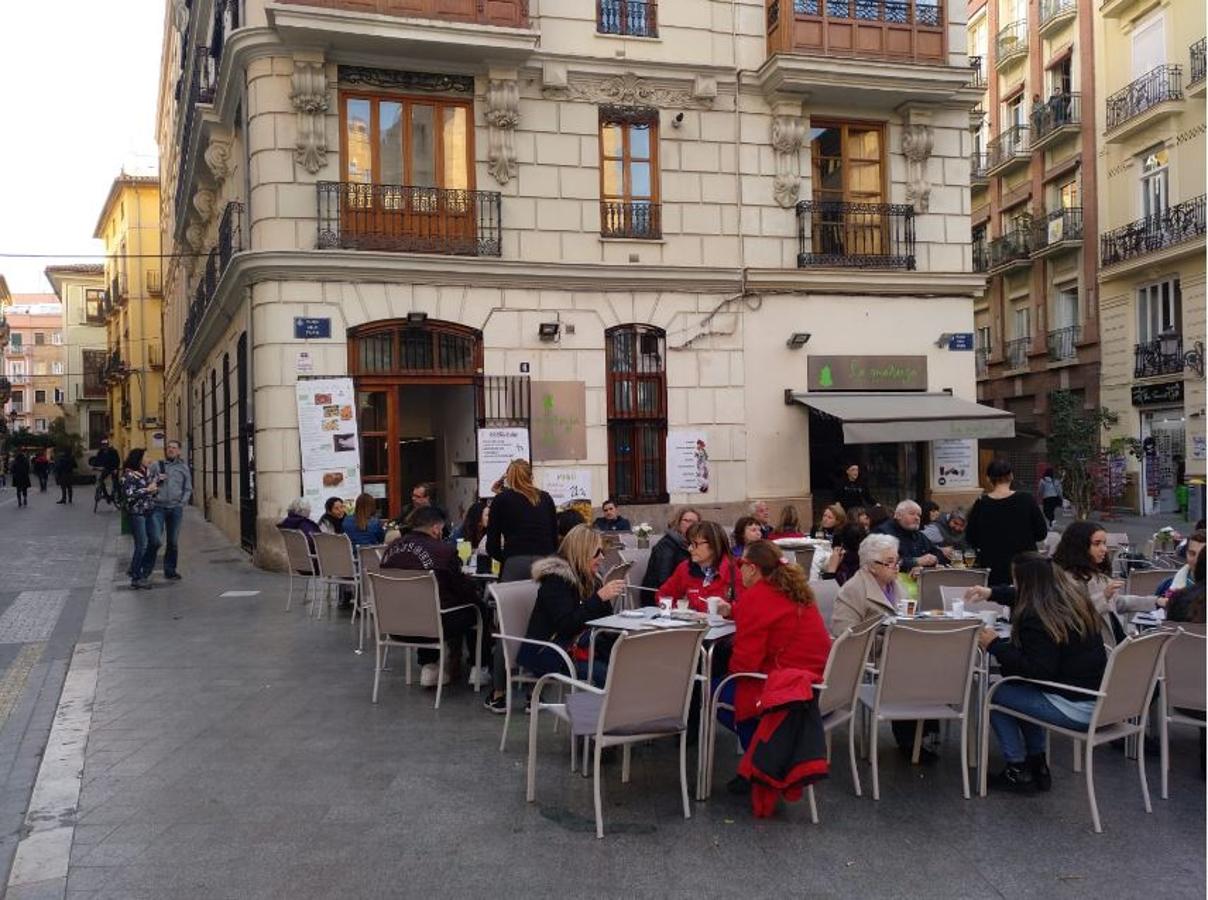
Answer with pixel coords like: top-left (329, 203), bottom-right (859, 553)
top-left (382, 506), bottom-right (489, 687)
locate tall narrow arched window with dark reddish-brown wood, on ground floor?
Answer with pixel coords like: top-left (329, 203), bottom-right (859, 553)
top-left (604, 325), bottom-right (668, 504)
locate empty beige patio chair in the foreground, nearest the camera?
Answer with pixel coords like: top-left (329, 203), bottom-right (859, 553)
top-left (525, 627), bottom-right (705, 837)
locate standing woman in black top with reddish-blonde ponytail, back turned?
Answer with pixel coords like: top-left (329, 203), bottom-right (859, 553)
top-left (487, 459), bottom-right (558, 581)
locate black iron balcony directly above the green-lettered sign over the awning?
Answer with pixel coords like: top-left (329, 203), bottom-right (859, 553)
top-left (797, 201), bottom-right (914, 271)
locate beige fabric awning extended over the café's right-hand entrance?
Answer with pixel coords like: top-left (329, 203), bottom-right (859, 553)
top-left (788, 391), bottom-right (1015, 443)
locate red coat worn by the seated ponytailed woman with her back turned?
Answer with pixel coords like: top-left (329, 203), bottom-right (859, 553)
top-left (730, 581), bottom-right (831, 721)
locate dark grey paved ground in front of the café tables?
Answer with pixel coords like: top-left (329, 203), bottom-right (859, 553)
top-left (49, 515), bottom-right (1204, 900)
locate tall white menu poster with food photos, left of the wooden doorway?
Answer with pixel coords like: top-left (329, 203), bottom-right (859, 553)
top-left (296, 378), bottom-right (361, 512)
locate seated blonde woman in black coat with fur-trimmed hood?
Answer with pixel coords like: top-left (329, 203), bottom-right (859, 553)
top-left (516, 524), bottom-right (625, 685)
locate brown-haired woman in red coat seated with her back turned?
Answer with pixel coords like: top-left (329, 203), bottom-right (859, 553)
top-left (718, 541), bottom-right (831, 750)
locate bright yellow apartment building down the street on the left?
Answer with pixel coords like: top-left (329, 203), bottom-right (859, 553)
top-left (93, 172), bottom-right (164, 459)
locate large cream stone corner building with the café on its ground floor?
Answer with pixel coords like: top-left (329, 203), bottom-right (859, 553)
top-left (158, 0), bottom-right (1014, 564)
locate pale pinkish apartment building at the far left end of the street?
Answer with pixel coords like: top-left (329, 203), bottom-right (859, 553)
top-left (4, 294), bottom-right (66, 434)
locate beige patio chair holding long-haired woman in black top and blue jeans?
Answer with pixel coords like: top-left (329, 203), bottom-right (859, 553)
top-left (980, 631), bottom-right (1174, 835)
